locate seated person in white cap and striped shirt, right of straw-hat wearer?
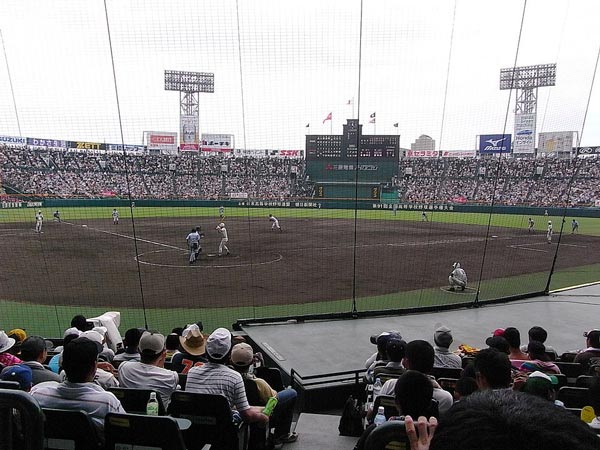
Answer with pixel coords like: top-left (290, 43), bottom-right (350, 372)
top-left (185, 328), bottom-right (269, 426)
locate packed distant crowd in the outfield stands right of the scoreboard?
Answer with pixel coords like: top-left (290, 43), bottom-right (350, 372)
top-left (396, 158), bottom-right (600, 206)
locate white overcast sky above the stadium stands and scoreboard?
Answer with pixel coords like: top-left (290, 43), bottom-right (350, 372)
top-left (0, 0), bottom-right (600, 150)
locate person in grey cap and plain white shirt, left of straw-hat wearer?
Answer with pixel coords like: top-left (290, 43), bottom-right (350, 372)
top-left (119, 331), bottom-right (179, 408)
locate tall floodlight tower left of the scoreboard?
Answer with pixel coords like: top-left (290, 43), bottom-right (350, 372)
top-left (165, 70), bottom-right (215, 151)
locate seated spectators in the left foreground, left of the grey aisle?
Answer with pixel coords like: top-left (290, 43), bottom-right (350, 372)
top-left (0, 315), bottom-right (298, 449)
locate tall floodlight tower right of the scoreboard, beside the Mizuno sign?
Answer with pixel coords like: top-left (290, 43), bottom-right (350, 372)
top-left (500, 64), bottom-right (556, 154)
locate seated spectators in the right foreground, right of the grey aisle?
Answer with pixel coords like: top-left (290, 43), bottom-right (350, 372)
top-left (355, 325), bottom-right (600, 450)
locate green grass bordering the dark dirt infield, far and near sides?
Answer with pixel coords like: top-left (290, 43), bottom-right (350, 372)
top-left (0, 207), bottom-right (600, 336)
